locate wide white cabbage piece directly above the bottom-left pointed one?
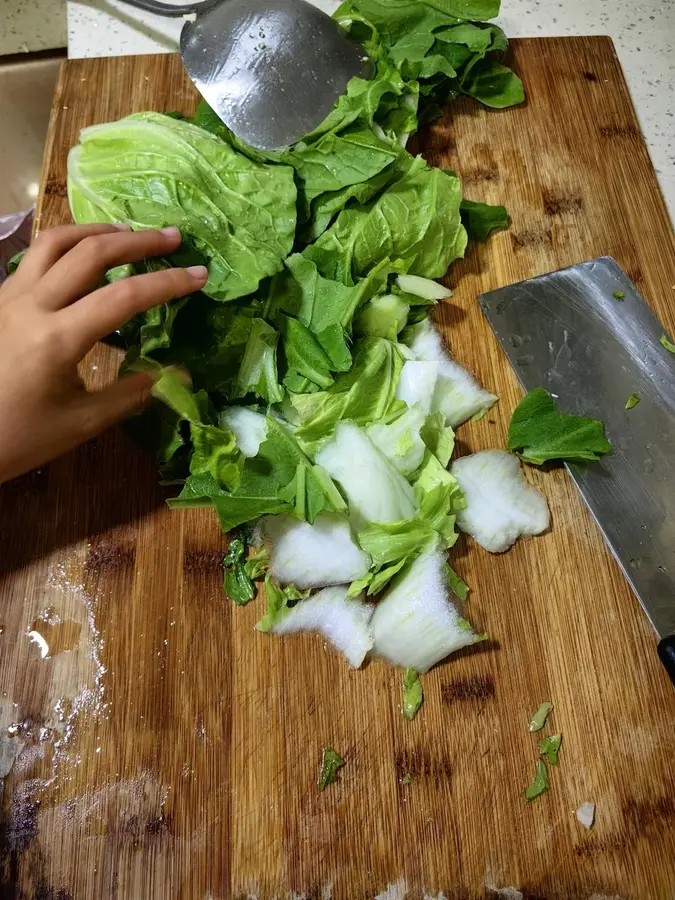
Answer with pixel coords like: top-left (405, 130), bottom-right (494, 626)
top-left (259, 512), bottom-right (370, 590)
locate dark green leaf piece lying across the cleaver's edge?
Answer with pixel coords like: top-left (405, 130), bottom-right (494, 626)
top-left (507, 388), bottom-right (612, 466)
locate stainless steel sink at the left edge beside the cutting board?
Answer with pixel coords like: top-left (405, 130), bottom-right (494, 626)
top-left (0, 50), bottom-right (66, 215)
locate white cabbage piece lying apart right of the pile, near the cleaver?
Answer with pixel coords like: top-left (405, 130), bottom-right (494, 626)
top-left (450, 450), bottom-right (550, 553)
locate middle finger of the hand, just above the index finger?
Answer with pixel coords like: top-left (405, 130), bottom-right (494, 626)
top-left (37, 227), bottom-right (181, 309)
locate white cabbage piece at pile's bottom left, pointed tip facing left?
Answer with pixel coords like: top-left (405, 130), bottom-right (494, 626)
top-left (268, 585), bottom-right (373, 668)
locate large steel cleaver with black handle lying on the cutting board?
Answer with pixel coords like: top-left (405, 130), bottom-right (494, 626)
top-left (479, 257), bottom-right (675, 684)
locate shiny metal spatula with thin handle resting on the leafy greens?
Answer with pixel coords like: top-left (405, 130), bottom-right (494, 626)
top-left (116, 0), bottom-right (373, 150)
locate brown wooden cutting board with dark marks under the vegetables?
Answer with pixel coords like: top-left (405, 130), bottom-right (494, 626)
top-left (0, 38), bottom-right (675, 900)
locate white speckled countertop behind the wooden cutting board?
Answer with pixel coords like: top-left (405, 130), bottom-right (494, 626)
top-left (62, 0), bottom-right (675, 219)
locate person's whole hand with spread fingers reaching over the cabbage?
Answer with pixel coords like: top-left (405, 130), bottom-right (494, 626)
top-left (0, 225), bottom-right (207, 483)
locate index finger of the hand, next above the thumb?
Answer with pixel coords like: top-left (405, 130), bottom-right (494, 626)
top-left (67, 266), bottom-right (208, 358)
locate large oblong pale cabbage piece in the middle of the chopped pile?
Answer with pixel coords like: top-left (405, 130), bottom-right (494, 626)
top-left (316, 422), bottom-right (417, 529)
